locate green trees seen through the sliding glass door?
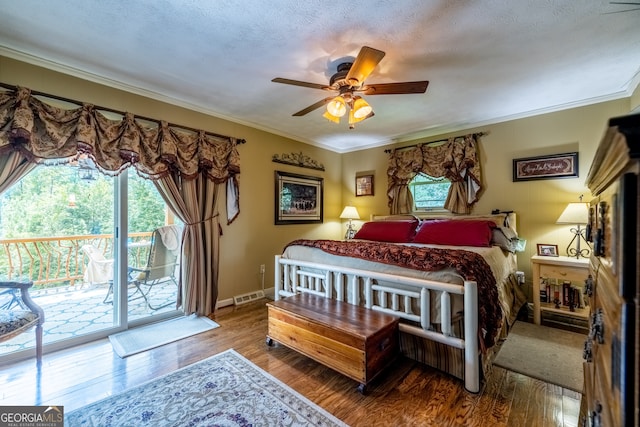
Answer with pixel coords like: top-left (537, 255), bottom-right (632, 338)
top-left (0, 165), bottom-right (165, 239)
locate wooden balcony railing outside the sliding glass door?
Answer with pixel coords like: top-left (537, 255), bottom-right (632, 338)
top-left (0, 232), bottom-right (151, 288)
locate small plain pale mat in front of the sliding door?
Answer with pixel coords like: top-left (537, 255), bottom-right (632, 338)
top-left (109, 314), bottom-right (220, 357)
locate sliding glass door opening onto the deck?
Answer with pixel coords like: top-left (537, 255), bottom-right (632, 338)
top-left (0, 162), bottom-right (182, 360)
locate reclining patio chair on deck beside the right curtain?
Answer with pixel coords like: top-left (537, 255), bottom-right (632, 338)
top-left (129, 225), bottom-right (182, 310)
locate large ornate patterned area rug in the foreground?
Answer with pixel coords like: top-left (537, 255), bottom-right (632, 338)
top-left (64, 349), bottom-right (346, 427)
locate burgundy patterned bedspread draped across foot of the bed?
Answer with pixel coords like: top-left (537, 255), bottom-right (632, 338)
top-left (287, 239), bottom-right (502, 351)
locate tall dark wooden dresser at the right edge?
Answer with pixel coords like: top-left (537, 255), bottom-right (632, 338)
top-left (584, 114), bottom-right (640, 427)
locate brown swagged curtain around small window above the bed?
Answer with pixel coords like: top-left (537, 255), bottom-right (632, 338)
top-left (387, 134), bottom-right (482, 215)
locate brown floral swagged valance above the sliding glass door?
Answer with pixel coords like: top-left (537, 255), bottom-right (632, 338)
top-left (0, 87), bottom-right (244, 220)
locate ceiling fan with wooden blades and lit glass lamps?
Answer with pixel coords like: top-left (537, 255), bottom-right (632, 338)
top-left (271, 46), bottom-right (429, 129)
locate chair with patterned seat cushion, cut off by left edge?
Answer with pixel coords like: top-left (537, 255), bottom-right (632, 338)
top-left (0, 278), bottom-right (44, 368)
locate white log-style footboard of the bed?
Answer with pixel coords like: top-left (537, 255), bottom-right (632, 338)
top-left (274, 255), bottom-right (480, 393)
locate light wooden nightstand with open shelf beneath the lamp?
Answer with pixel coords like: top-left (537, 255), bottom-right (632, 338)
top-left (531, 255), bottom-right (589, 325)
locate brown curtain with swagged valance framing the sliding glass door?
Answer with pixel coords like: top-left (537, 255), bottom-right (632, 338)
top-left (0, 87), bottom-right (241, 315)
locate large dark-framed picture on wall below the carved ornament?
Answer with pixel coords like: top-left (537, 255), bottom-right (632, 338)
top-left (275, 171), bottom-right (324, 225)
